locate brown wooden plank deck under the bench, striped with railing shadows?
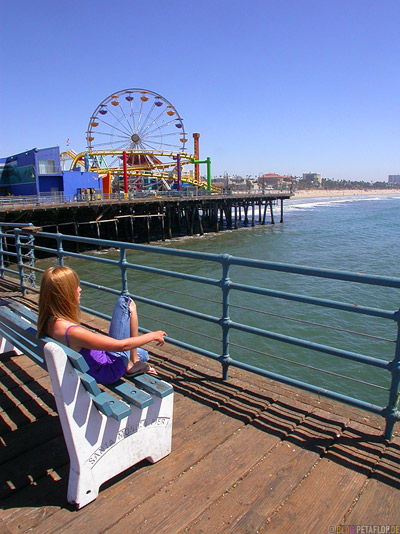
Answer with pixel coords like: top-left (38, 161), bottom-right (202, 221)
top-left (0, 281), bottom-right (400, 534)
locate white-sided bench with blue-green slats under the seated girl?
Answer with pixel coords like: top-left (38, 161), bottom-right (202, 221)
top-left (0, 303), bottom-right (173, 509)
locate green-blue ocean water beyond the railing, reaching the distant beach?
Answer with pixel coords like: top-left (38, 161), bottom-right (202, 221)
top-left (39, 194), bottom-right (400, 406)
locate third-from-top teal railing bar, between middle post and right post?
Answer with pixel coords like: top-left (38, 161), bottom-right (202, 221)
top-left (229, 321), bottom-right (389, 369)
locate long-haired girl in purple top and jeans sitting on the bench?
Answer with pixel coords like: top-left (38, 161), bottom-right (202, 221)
top-left (38, 267), bottom-right (167, 384)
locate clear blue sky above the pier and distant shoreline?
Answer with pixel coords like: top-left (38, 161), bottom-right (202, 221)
top-left (0, 0), bottom-right (400, 181)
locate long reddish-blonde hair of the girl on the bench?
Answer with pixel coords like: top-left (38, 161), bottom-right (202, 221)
top-left (37, 267), bottom-right (80, 337)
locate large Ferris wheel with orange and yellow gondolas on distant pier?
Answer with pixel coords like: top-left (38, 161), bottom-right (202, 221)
top-left (86, 89), bottom-right (187, 171)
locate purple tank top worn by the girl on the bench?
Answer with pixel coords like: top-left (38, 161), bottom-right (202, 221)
top-left (65, 325), bottom-right (127, 384)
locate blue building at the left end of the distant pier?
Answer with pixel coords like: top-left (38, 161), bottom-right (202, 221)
top-left (0, 146), bottom-right (101, 198)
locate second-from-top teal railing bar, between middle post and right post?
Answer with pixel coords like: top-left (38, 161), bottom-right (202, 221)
top-left (229, 282), bottom-right (395, 320)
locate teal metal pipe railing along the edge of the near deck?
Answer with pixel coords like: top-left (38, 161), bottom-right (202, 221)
top-left (0, 223), bottom-right (400, 439)
